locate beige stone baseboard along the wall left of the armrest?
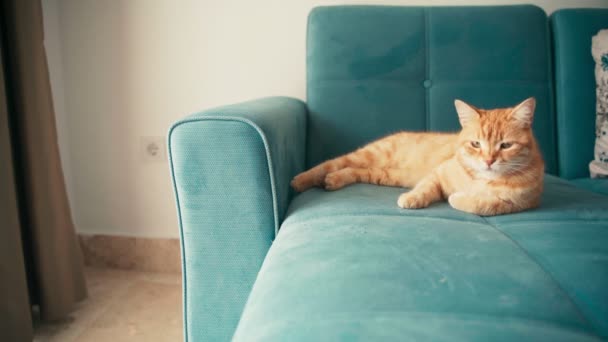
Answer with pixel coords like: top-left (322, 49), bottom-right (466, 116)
top-left (78, 234), bottom-right (181, 273)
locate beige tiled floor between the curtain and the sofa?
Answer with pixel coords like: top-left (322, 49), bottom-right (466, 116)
top-left (34, 268), bottom-right (183, 342)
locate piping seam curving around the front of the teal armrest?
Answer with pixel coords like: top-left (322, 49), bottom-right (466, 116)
top-left (167, 115), bottom-right (279, 342)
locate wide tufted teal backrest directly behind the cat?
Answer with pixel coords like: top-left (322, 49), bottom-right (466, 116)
top-left (306, 5), bottom-right (557, 173)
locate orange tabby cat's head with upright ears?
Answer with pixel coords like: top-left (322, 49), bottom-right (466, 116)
top-left (454, 98), bottom-right (539, 179)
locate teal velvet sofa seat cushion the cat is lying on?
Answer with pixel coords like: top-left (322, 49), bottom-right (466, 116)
top-left (234, 177), bottom-right (608, 341)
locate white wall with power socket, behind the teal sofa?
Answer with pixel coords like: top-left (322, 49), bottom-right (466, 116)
top-left (43, 0), bottom-right (608, 237)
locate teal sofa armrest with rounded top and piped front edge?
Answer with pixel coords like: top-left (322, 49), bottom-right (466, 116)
top-left (168, 97), bottom-right (307, 341)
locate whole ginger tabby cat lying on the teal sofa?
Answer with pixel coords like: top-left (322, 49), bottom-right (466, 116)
top-left (291, 98), bottom-right (544, 216)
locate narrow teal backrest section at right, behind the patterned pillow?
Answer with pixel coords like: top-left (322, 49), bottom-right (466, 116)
top-left (551, 9), bottom-right (608, 178)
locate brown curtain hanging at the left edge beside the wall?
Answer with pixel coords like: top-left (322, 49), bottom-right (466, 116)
top-left (0, 0), bottom-right (86, 336)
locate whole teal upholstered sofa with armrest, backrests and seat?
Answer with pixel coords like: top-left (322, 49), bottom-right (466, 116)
top-left (169, 5), bottom-right (608, 342)
